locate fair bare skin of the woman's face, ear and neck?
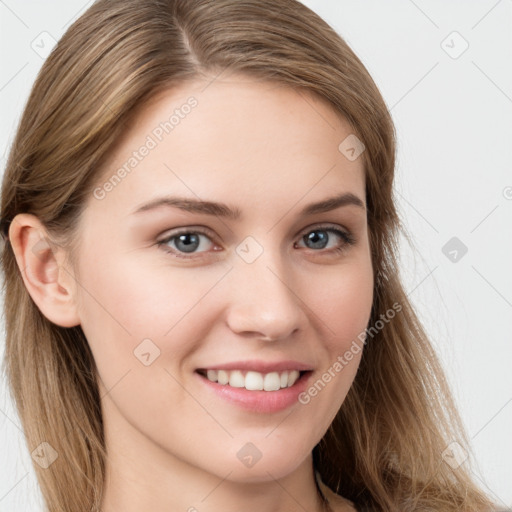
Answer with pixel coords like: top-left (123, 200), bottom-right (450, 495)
top-left (9, 75), bottom-right (373, 512)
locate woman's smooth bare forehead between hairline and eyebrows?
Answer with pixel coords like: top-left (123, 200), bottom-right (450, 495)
top-left (87, 76), bottom-right (364, 222)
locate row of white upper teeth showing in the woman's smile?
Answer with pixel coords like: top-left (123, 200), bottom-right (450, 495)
top-left (202, 370), bottom-right (300, 391)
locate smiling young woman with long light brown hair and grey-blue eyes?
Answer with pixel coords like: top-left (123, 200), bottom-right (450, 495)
top-left (2, 0), bottom-right (498, 512)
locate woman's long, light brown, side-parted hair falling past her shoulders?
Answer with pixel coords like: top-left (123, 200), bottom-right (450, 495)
top-left (1, 0), bottom-right (492, 512)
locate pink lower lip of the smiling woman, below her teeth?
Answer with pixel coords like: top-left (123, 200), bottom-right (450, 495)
top-left (195, 371), bottom-right (313, 413)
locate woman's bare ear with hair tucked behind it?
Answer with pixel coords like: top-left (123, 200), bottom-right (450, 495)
top-left (9, 213), bottom-right (80, 327)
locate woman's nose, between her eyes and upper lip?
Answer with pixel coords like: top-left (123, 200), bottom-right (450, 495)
top-left (227, 251), bottom-right (306, 341)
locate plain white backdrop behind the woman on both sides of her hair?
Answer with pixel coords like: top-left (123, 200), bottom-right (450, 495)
top-left (0, 0), bottom-right (512, 512)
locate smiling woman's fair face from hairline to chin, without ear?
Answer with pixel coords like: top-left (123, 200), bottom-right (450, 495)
top-left (70, 77), bottom-right (373, 481)
